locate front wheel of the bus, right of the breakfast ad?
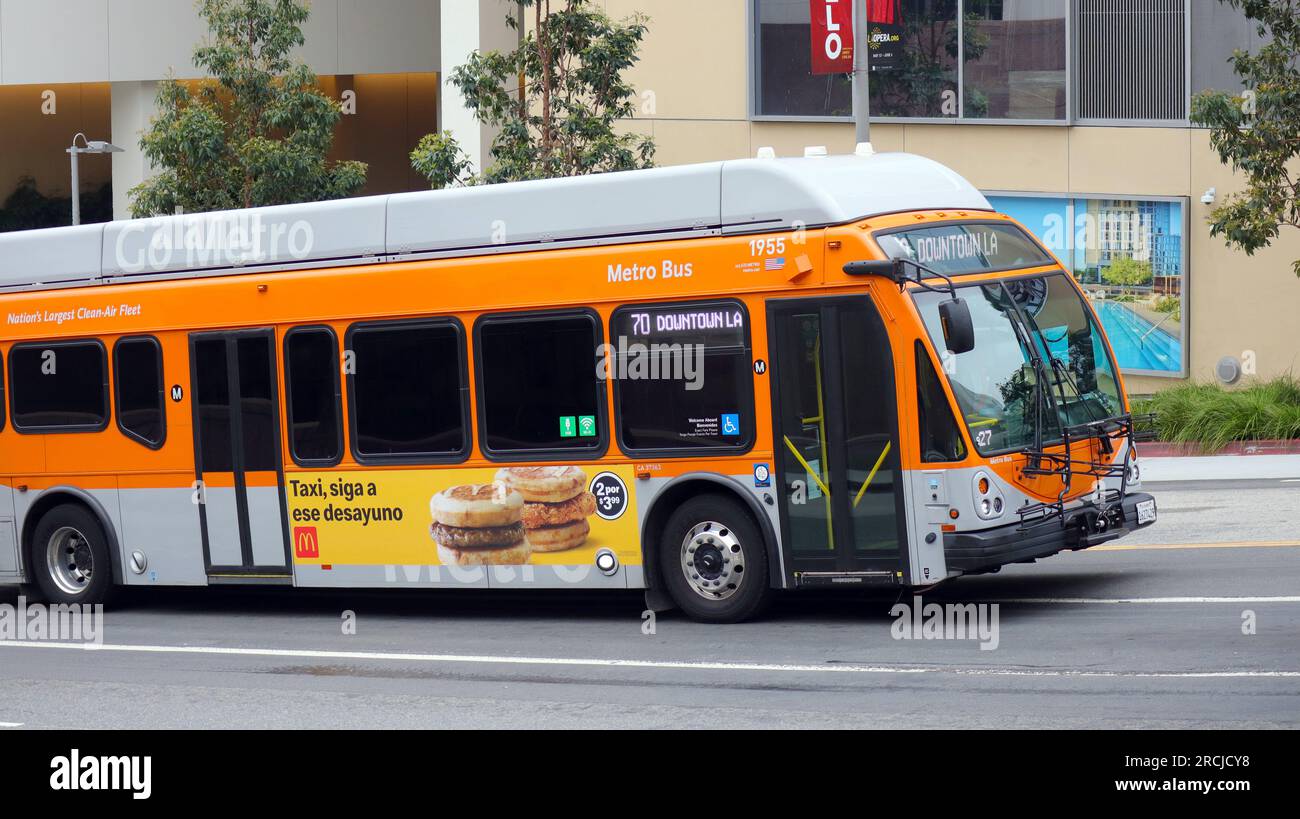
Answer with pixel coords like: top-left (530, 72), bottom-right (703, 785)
top-left (659, 494), bottom-right (772, 623)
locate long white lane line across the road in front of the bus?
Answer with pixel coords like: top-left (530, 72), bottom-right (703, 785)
top-left (0, 640), bottom-right (1300, 680)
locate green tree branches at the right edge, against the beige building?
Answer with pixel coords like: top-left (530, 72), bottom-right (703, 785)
top-left (1192, 0), bottom-right (1300, 276)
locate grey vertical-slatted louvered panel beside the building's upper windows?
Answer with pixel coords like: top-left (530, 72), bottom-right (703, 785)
top-left (1075, 0), bottom-right (1188, 121)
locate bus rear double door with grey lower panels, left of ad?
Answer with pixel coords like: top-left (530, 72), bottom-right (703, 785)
top-left (190, 330), bottom-right (290, 582)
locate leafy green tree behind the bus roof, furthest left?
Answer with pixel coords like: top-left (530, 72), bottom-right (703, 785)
top-left (130, 0), bottom-right (367, 217)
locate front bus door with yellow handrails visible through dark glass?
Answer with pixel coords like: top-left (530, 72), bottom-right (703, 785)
top-left (767, 296), bottom-right (907, 585)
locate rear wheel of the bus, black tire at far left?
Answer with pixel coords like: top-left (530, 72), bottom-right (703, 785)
top-left (27, 503), bottom-right (114, 605)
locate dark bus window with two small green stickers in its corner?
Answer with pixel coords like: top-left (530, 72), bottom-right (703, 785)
top-left (475, 312), bottom-right (607, 458)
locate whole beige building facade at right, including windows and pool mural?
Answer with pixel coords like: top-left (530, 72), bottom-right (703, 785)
top-left (606, 0), bottom-right (1300, 394)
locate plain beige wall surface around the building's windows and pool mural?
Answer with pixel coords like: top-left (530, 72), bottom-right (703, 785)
top-left (603, 0), bottom-right (1300, 393)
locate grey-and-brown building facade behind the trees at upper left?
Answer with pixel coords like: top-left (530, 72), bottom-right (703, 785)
top-left (0, 0), bottom-right (519, 221)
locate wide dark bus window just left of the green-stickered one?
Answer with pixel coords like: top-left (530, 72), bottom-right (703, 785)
top-left (346, 320), bottom-right (469, 463)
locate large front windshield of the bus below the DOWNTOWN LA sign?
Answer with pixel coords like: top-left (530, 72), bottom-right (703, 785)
top-left (914, 273), bottom-right (1125, 455)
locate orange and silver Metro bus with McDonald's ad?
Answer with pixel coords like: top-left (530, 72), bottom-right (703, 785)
top-left (0, 146), bottom-right (1156, 621)
